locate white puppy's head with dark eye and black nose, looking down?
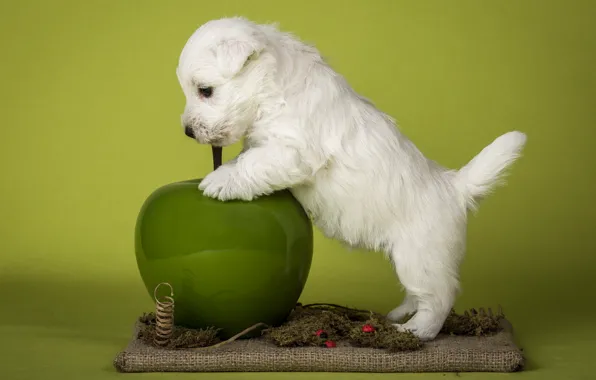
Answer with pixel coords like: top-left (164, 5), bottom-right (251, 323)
top-left (176, 18), bottom-right (267, 146)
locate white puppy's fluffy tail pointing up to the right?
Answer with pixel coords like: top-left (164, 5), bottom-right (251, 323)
top-left (456, 131), bottom-right (526, 210)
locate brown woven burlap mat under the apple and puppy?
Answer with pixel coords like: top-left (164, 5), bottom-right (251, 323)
top-left (114, 320), bottom-right (524, 372)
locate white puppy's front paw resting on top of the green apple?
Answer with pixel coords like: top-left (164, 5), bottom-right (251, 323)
top-left (199, 165), bottom-right (253, 201)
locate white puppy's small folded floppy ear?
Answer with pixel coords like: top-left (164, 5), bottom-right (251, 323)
top-left (215, 40), bottom-right (261, 78)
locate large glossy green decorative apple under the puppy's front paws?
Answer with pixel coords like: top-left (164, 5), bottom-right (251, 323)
top-left (135, 179), bottom-right (313, 338)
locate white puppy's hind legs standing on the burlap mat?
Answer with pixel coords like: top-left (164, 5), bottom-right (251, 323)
top-left (388, 233), bottom-right (459, 340)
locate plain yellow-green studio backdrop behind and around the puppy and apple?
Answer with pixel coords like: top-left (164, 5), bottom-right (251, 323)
top-left (0, 0), bottom-right (596, 380)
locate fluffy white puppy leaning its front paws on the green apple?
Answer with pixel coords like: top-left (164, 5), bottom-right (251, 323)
top-left (177, 18), bottom-right (526, 340)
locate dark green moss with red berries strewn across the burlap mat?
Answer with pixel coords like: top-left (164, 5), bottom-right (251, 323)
top-left (139, 304), bottom-right (504, 352)
